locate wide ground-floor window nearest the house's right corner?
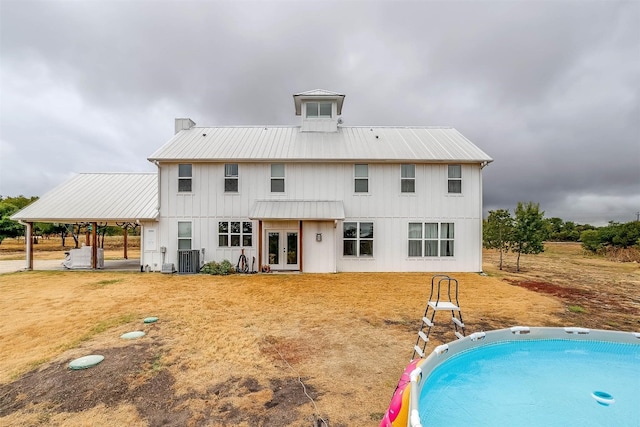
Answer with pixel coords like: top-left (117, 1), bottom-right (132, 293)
top-left (408, 222), bottom-right (455, 257)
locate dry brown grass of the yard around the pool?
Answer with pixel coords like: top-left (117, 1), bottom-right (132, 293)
top-left (0, 245), bottom-right (640, 427)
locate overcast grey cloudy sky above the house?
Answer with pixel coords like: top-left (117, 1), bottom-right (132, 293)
top-left (0, 0), bottom-right (640, 225)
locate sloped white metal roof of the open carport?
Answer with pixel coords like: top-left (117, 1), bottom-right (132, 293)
top-left (11, 173), bottom-right (158, 223)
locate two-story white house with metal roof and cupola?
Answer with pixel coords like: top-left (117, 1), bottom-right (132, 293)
top-left (141, 90), bottom-right (492, 272)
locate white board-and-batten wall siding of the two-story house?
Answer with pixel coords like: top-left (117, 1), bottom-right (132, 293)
top-left (145, 161), bottom-right (482, 272)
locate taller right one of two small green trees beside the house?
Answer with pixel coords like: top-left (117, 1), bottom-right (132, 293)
top-left (511, 202), bottom-right (546, 271)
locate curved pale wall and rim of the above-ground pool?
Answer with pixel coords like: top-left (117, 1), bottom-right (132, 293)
top-left (381, 326), bottom-right (640, 427)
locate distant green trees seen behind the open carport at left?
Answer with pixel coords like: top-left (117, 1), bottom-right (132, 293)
top-left (0, 195), bottom-right (139, 248)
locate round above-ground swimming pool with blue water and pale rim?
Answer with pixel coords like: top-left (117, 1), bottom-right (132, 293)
top-left (381, 327), bottom-right (640, 427)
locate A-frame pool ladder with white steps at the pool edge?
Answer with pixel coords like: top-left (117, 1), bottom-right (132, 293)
top-left (411, 274), bottom-right (465, 360)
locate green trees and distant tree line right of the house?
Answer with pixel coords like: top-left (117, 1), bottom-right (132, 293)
top-left (482, 202), bottom-right (640, 271)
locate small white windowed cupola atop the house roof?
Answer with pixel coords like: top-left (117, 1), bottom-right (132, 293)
top-left (293, 89), bottom-right (344, 132)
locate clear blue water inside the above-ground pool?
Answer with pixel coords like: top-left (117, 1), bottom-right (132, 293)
top-left (418, 339), bottom-right (640, 427)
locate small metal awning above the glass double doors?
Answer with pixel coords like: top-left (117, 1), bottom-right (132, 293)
top-left (249, 200), bottom-right (344, 221)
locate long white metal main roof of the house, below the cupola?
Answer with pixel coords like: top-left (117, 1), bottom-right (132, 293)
top-left (149, 126), bottom-right (493, 163)
